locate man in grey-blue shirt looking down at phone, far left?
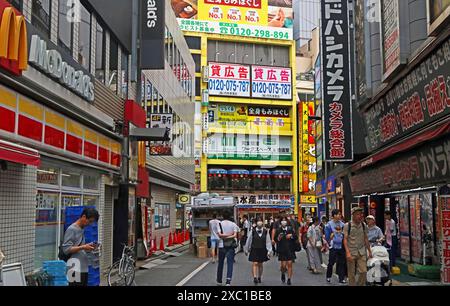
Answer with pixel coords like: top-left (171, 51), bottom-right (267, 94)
top-left (62, 208), bottom-right (99, 286)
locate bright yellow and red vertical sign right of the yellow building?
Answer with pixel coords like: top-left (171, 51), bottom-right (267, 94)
top-left (299, 102), bottom-right (317, 194)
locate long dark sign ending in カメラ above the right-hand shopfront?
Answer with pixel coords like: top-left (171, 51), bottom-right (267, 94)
top-left (350, 134), bottom-right (450, 195)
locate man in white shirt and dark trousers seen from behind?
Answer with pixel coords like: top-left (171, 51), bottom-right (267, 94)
top-left (217, 212), bottom-right (239, 286)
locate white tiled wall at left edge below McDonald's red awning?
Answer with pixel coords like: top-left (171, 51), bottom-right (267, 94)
top-left (0, 163), bottom-right (36, 274)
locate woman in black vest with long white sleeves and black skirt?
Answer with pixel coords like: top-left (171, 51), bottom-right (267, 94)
top-left (244, 218), bottom-right (272, 285)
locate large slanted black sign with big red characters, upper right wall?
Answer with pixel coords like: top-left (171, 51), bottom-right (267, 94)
top-left (364, 35), bottom-right (450, 150)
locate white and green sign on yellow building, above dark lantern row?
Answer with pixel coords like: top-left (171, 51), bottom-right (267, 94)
top-left (207, 133), bottom-right (292, 161)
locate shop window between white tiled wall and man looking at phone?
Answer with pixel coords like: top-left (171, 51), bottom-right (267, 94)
top-left (34, 190), bottom-right (59, 268)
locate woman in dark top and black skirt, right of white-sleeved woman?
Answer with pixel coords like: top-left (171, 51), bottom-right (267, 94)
top-left (275, 217), bottom-right (298, 285)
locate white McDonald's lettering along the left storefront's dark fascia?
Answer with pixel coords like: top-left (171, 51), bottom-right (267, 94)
top-left (29, 35), bottom-right (95, 102)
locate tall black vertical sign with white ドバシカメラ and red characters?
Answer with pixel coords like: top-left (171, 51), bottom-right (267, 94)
top-left (321, 0), bottom-right (353, 161)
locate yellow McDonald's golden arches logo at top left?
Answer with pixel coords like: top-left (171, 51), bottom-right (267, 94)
top-left (0, 7), bottom-right (28, 70)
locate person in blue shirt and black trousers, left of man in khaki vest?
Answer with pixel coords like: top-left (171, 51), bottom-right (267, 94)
top-left (325, 209), bottom-right (345, 283)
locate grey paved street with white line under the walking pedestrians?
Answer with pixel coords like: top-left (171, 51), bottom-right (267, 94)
top-left (136, 246), bottom-right (341, 286)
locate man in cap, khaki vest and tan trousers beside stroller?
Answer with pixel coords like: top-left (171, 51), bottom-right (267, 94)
top-left (344, 207), bottom-right (372, 286)
